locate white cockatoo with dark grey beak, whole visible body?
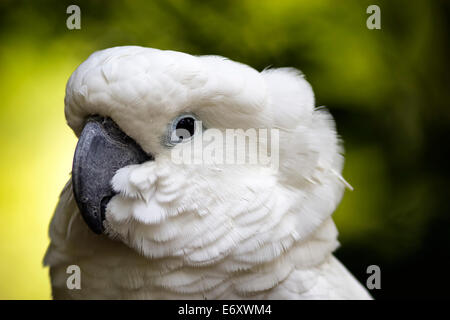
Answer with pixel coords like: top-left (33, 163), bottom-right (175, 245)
top-left (44, 46), bottom-right (371, 299)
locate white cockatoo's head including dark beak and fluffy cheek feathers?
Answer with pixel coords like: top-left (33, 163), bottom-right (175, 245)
top-left (65, 46), bottom-right (344, 268)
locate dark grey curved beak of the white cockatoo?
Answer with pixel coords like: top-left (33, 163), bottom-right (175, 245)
top-left (72, 116), bottom-right (153, 234)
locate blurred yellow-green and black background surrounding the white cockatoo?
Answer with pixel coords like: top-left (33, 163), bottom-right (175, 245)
top-left (0, 0), bottom-right (450, 299)
